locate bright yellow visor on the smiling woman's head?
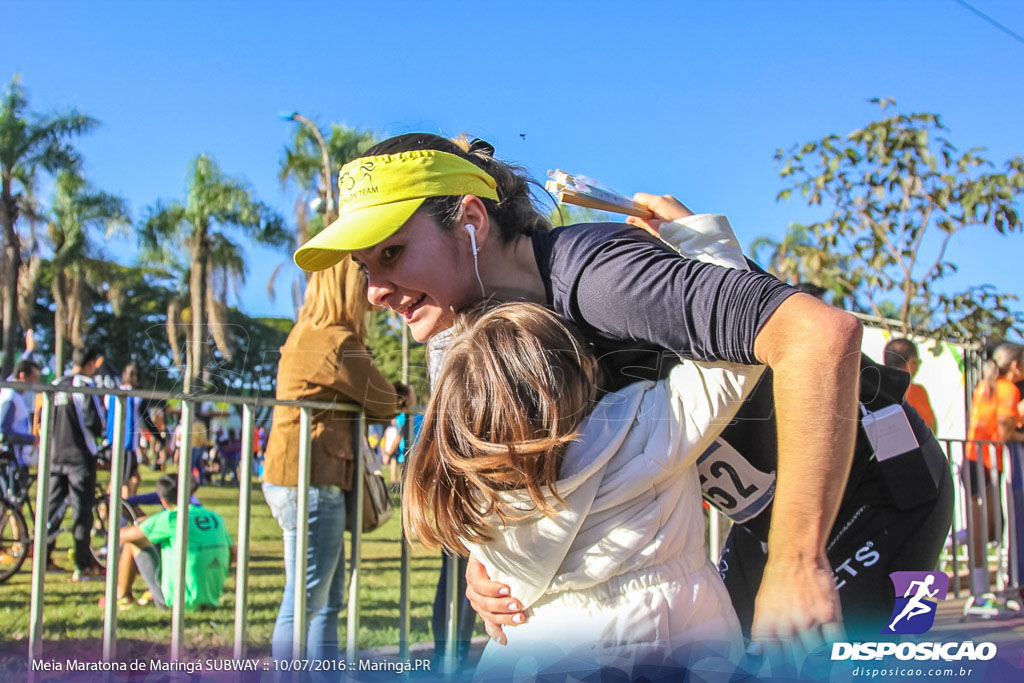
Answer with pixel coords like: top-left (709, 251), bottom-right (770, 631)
top-left (295, 150), bottom-right (498, 270)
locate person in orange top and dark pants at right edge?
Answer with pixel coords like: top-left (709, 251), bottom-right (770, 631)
top-left (964, 343), bottom-right (1024, 595)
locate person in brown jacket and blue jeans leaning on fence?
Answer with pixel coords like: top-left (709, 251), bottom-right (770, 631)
top-left (263, 258), bottom-right (415, 660)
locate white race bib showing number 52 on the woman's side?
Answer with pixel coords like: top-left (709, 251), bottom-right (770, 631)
top-left (697, 438), bottom-right (775, 524)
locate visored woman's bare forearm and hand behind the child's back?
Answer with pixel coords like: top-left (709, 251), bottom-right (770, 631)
top-left (752, 294), bottom-right (861, 647)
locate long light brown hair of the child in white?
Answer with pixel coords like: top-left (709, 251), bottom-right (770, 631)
top-left (402, 303), bottom-right (597, 554)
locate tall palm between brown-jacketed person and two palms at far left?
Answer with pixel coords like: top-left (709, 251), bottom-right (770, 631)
top-left (139, 155), bottom-right (292, 391)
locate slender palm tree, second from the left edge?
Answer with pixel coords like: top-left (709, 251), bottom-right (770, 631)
top-left (47, 171), bottom-right (131, 374)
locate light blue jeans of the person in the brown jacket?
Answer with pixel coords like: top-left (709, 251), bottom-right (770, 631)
top-left (263, 482), bottom-right (346, 671)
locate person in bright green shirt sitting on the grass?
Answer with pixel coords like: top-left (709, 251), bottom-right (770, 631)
top-left (99, 474), bottom-right (234, 609)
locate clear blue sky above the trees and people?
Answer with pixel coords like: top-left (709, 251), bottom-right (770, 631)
top-left (0, 0), bottom-right (1024, 325)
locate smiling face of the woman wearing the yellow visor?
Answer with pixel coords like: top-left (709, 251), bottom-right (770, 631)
top-left (352, 211), bottom-right (480, 342)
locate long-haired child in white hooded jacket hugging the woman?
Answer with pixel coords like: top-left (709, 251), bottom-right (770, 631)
top-left (403, 217), bottom-right (761, 680)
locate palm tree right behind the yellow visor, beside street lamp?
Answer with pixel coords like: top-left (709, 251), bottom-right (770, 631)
top-left (266, 123), bottom-right (377, 314)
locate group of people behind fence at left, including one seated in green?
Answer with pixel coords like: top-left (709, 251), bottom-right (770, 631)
top-left (0, 331), bottom-right (267, 609)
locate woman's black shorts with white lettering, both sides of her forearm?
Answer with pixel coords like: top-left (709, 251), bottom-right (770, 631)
top-left (719, 421), bottom-right (953, 640)
